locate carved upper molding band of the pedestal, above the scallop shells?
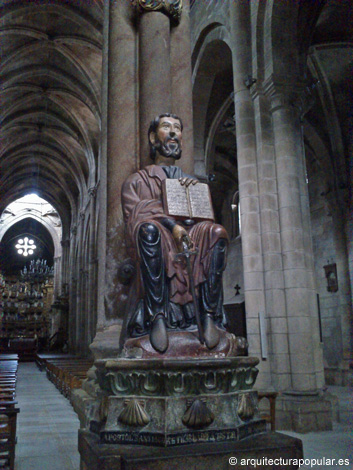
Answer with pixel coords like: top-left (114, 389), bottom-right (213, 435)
top-left (96, 357), bottom-right (258, 397)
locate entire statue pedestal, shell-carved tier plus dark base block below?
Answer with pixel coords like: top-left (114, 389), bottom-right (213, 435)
top-left (79, 356), bottom-right (302, 470)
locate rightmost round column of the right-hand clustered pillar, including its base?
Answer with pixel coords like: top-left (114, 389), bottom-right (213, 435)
top-left (263, 82), bottom-right (332, 432)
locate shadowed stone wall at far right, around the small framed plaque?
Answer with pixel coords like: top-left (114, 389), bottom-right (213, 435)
top-left (309, 162), bottom-right (351, 385)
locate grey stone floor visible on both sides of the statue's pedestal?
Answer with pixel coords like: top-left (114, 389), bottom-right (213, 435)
top-left (15, 363), bottom-right (353, 470)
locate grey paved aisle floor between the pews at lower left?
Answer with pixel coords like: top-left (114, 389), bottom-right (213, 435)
top-left (15, 362), bottom-right (80, 470)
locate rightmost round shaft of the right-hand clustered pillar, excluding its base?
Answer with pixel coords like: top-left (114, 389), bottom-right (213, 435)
top-left (266, 82), bottom-right (324, 392)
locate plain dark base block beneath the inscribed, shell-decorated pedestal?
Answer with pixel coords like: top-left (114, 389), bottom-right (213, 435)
top-left (78, 430), bottom-right (303, 470)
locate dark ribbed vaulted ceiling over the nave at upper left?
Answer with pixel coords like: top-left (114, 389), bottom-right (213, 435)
top-left (0, 0), bottom-right (103, 233)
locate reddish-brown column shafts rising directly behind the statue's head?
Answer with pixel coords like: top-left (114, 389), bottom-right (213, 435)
top-left (137, 0), bottom-right (194, 173)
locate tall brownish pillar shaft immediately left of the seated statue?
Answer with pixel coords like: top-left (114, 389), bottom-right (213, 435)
top-left (91, 1), bottom-right (138, 356)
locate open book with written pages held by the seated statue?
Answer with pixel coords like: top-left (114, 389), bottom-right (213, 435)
top-left (162, 179), bottom-right (214, 220)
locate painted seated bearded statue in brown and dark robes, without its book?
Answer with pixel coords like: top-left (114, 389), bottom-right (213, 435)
top-left (122, 114), bottom-right (228, 353)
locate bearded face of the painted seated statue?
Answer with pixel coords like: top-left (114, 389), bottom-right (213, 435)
top-left (150, 117), bottom-right (182, 160)
